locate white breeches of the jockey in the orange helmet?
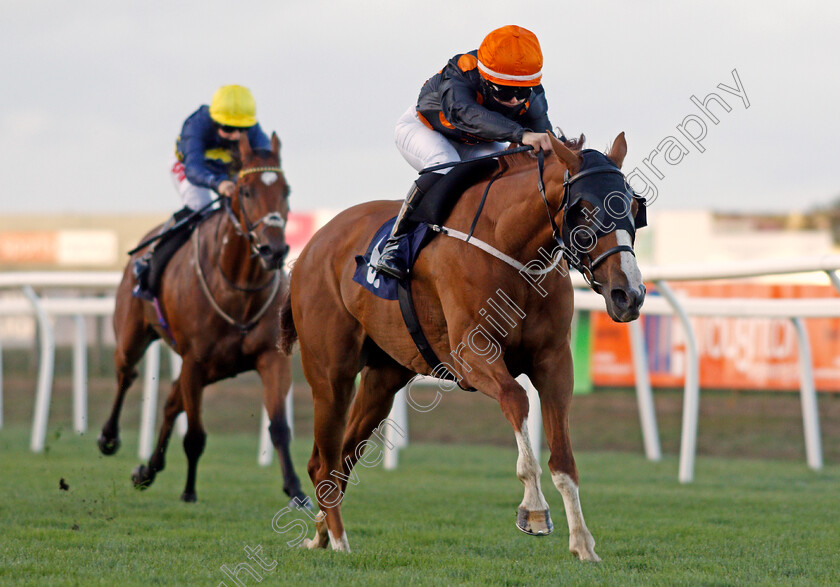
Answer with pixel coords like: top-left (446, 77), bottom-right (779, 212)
top-left (394, 106), bottom-right (508, 173)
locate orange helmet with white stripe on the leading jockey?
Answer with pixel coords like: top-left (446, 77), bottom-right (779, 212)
top-left (478, 25), bottom-right (542, 87)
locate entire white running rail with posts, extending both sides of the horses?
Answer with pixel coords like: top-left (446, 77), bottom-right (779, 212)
top-left (0, 255), bottom-right (840, 483)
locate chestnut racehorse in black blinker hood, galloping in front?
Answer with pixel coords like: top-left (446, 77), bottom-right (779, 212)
top-left (281, 133), bottom-right (645, 561)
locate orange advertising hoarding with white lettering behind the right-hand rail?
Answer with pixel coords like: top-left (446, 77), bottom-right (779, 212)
top-left (591, 283), bottom-right (840, 391)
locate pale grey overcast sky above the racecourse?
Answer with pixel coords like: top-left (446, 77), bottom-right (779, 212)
top-left (0, 0), bottom-right (840, 213)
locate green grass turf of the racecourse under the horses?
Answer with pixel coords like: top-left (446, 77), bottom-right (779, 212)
top-left (0, 426), bottom-right (840, 586)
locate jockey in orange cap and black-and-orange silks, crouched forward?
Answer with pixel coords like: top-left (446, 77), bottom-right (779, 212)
top-left (376, 25), bottom-right (551, 279)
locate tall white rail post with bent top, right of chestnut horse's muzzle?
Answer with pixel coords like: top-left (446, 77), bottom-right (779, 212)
top-left (656, 281), bottom-right (700, 483)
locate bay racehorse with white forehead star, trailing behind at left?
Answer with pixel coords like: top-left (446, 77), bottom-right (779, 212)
top-left (98, 134), bottom-right (308, 504)
